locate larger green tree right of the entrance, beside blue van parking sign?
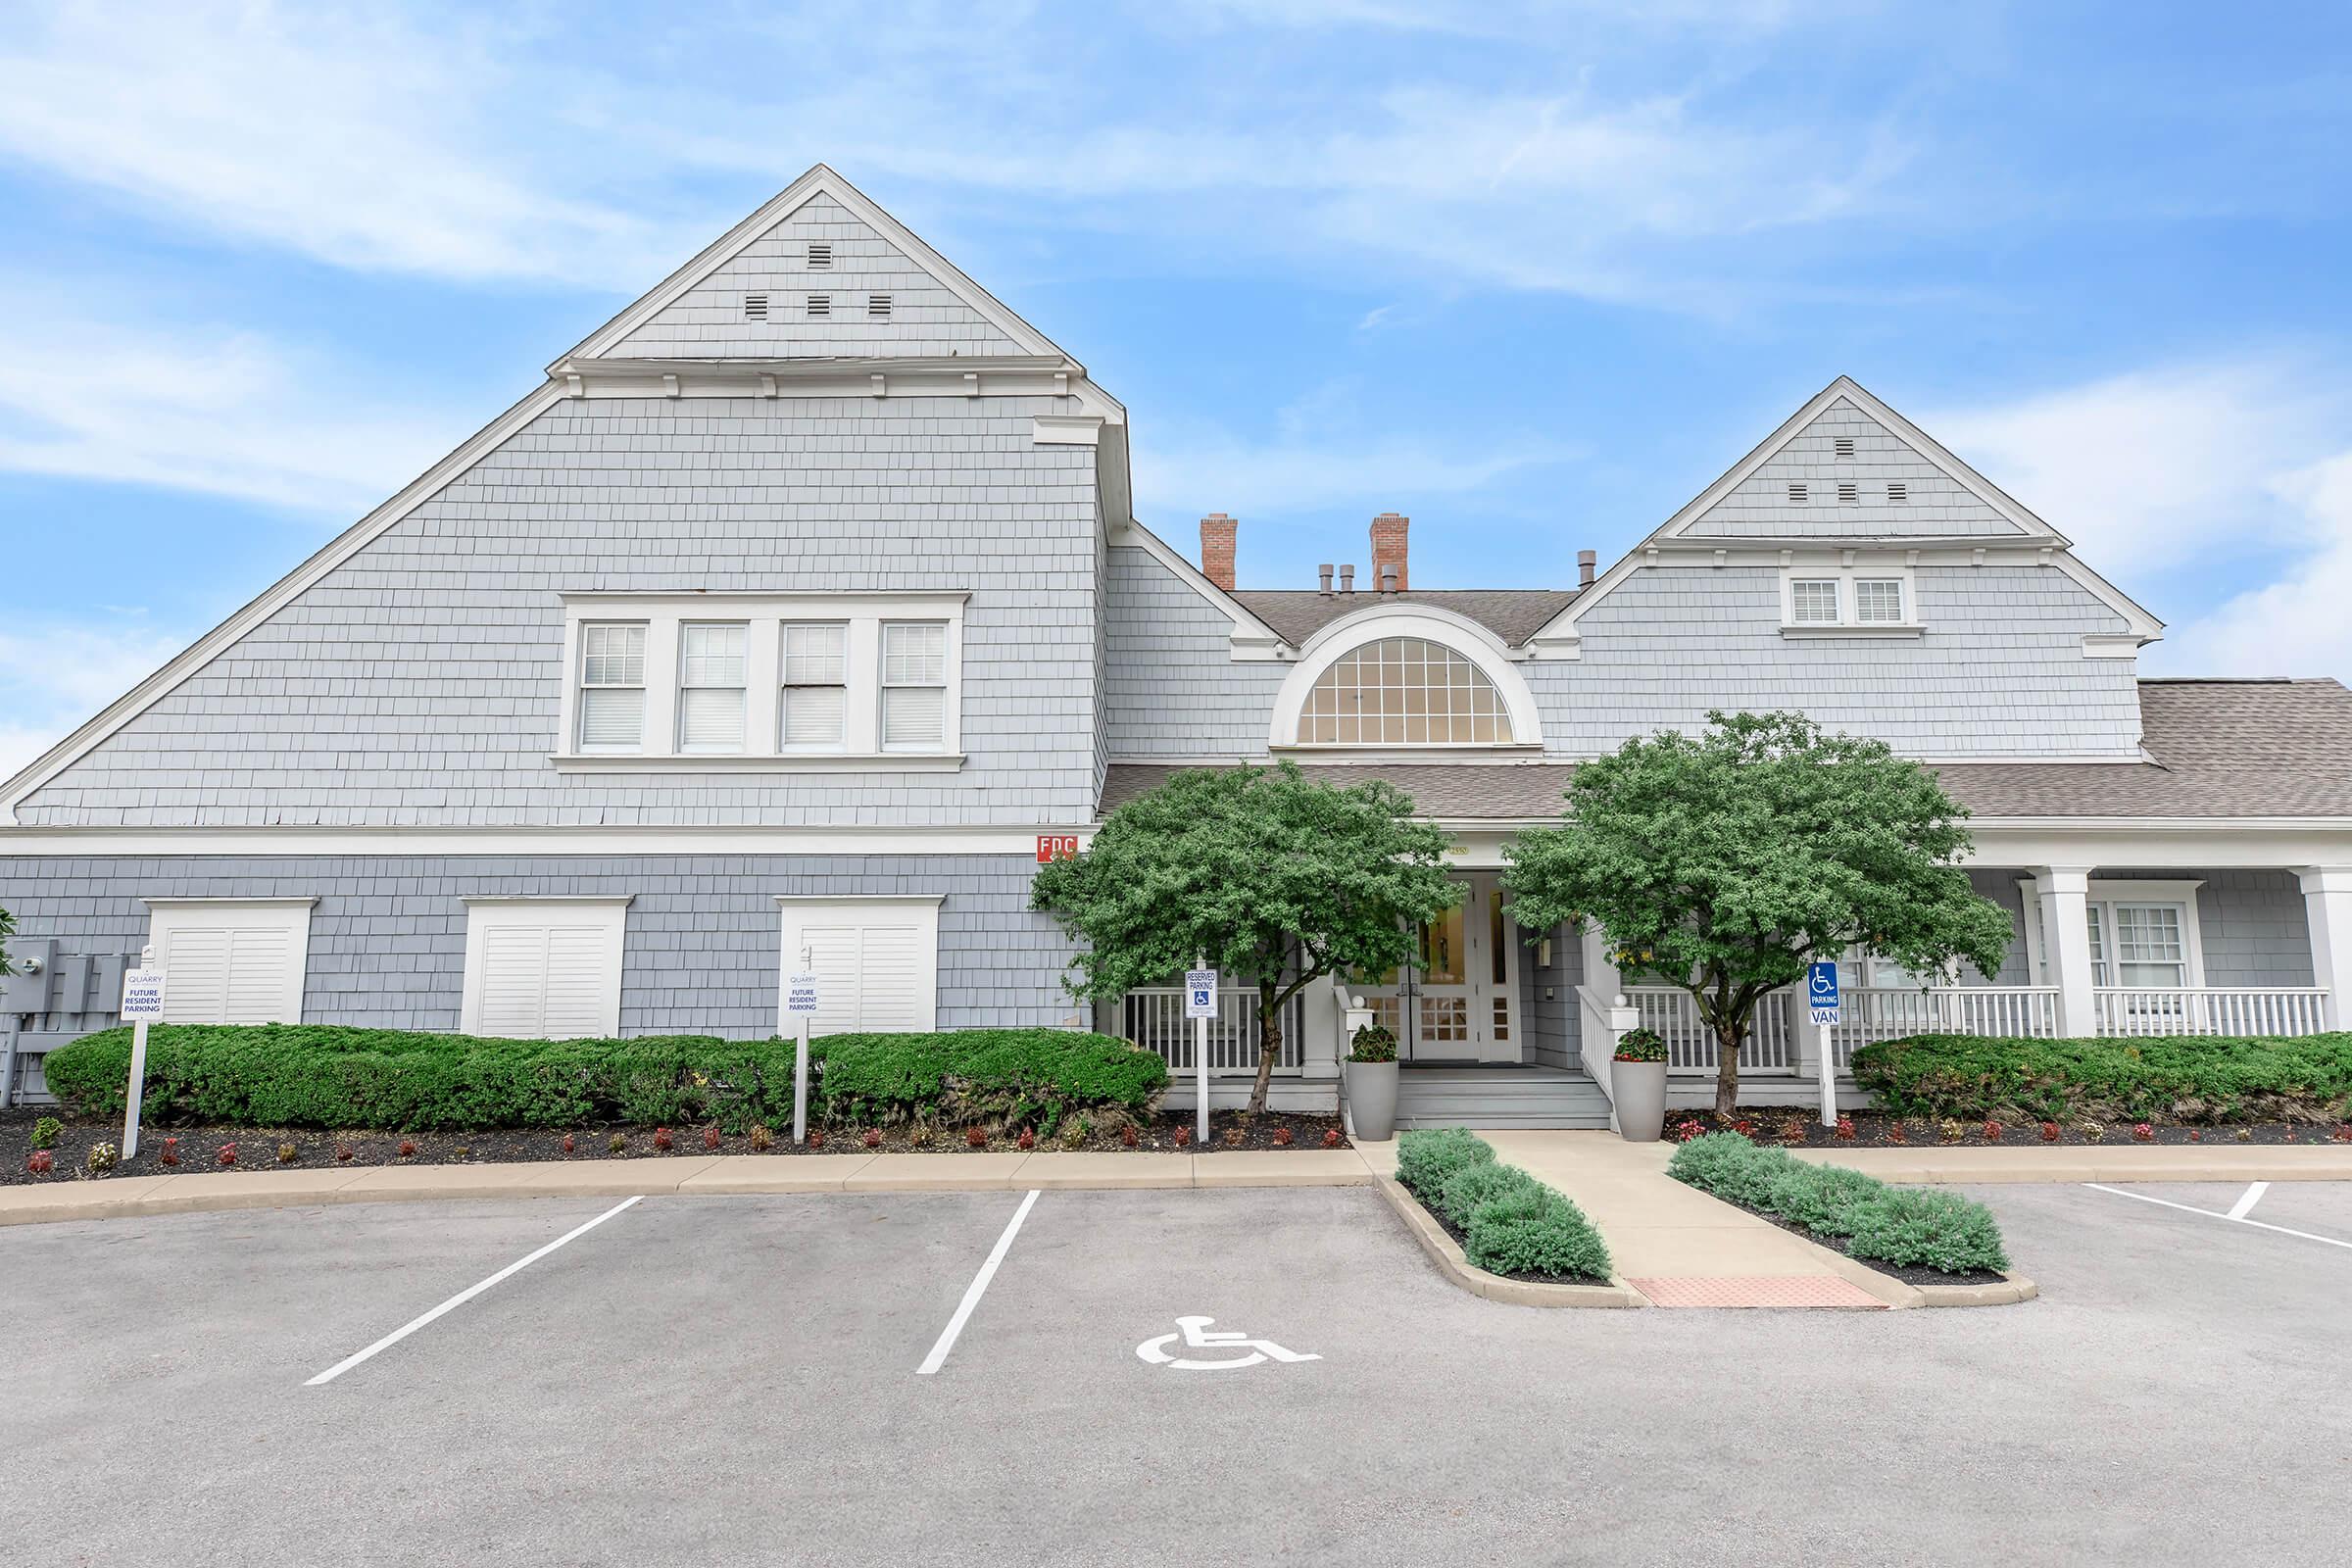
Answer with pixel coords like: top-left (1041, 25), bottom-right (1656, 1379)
top-left (1503, 712), bottom-right (2011, 1112)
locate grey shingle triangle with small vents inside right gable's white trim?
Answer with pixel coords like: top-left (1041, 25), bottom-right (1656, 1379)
top-left (1684, 397), bottom-right (2021, 538)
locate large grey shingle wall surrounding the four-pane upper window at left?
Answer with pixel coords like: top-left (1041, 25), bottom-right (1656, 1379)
top-left (19, 397), bottom-right (1099, 825)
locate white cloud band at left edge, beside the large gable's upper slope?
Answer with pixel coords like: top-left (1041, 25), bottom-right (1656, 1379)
top-left (0, 284), bottom-right (464, 514)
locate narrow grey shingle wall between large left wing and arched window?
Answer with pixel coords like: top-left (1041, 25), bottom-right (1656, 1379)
top-left (1103, 546), bottom-right (1292, 757)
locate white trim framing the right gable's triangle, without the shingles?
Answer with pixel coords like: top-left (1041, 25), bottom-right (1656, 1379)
top-left (1527, 376), bottom-right (2164, 659)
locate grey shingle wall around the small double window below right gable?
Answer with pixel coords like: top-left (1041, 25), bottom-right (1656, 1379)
top-left (1519, 566), bottom-right (2140, 757)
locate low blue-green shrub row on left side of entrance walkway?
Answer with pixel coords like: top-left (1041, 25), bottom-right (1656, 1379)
top-left (1397, 1126), bottom-right (1609, 1281)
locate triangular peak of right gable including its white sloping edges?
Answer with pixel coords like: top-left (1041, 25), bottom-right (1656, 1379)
top-left (1656, 376), bottom-right (2065, 546)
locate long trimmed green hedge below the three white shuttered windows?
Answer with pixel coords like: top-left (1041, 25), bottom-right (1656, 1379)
top-left (42, 1025), bottom-right (1166, 1131)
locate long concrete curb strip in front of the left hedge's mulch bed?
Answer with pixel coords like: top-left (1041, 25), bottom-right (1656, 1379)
top-left (0, 1150), bottom-right (1376, 1227)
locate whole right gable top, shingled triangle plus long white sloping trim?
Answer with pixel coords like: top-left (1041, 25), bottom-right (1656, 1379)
top-left (1529, 376), bottom-right (2164, 649)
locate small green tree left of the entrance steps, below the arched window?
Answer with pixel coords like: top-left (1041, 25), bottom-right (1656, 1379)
top-left (1030, 761), bottom-right (1458, 1116)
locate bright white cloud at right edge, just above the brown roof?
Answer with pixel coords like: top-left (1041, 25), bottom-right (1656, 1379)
top-left (2157, 452), bottom-right (2352, 682)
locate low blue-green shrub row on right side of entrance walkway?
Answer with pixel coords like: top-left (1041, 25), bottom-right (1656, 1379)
top-left (1665, 1133), bottom-right (2009, 1274)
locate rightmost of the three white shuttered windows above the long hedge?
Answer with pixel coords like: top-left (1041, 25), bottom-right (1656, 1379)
top-left (776, 894), bottom-right (941, 1034)
